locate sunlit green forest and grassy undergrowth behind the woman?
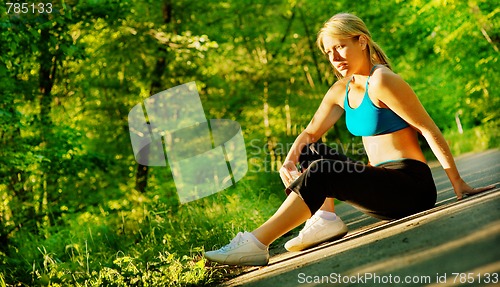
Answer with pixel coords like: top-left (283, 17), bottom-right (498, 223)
top-left (0, 0), bottom-right (500, 286)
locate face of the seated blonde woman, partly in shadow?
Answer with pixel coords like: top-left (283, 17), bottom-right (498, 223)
top-left (323, 36), bottom-right (367, 77)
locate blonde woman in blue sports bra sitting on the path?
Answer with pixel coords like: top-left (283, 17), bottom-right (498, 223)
top-left (205, 13), bottom-right (494, 265)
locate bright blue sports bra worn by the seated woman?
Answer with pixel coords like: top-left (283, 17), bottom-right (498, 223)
top-left (344, 66), bottom-right (410, 136)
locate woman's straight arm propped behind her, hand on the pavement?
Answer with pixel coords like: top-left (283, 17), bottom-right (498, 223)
top-left (370, 70), bottom-right (494, 199)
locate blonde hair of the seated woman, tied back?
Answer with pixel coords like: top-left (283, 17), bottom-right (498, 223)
top-left (316, 13), bottom-right (392, 79)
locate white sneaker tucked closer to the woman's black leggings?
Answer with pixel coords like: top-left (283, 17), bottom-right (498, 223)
top-left (285, 214), bottom-right (347, 251)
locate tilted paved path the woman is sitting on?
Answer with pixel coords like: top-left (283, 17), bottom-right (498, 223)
top-left (224, 149), bottom-right (500, 287)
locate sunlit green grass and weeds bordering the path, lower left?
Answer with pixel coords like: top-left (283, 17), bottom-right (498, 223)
top-left (0, 170), bottom-right (285, 286)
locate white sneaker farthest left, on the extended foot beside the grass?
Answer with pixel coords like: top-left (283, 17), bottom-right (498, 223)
top-left (205, 231), bottom-right (269, 266)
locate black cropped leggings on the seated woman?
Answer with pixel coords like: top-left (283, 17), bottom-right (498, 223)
top-left (286, 143), bottom-right (437, 220)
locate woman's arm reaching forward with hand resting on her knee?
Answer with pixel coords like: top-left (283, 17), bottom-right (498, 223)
top-left (280, 81), bottom-right (344, 186)
